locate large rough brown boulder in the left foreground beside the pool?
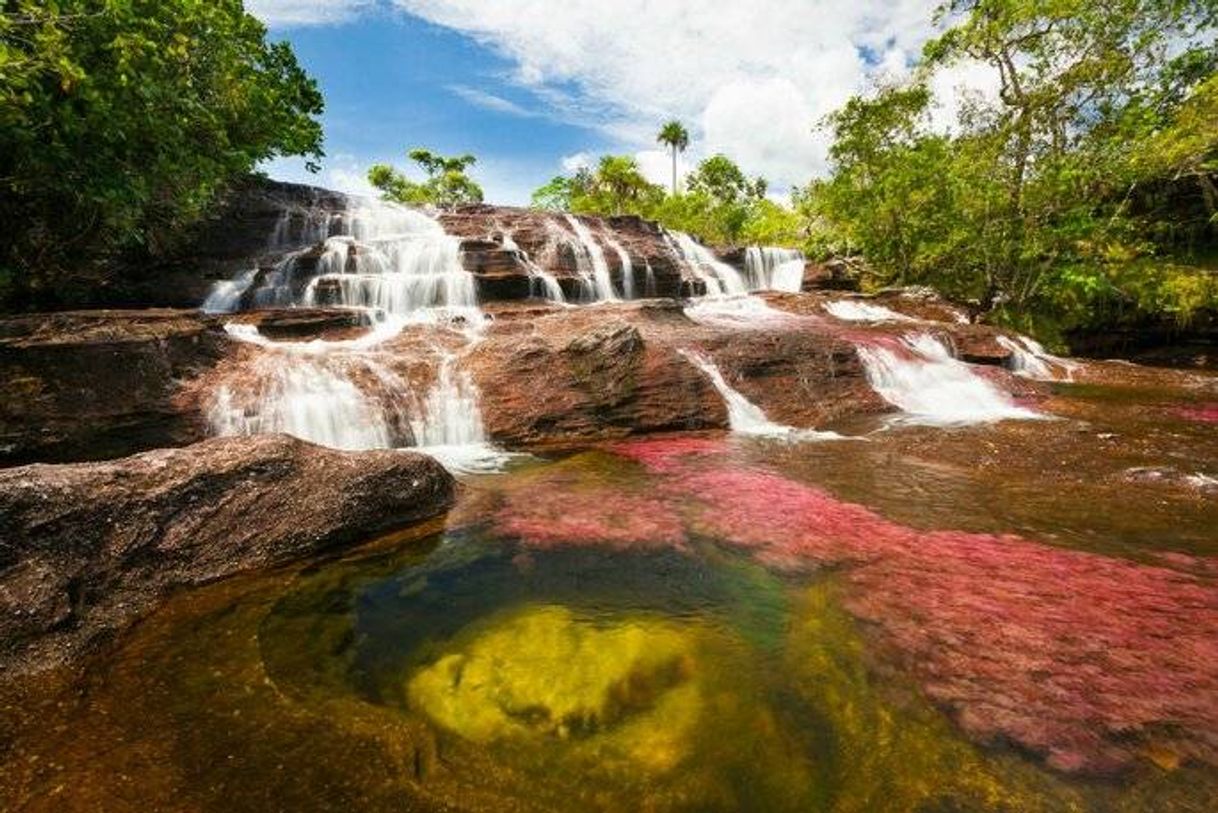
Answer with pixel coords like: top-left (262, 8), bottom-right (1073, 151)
top-left (0, 435), bottom-right (454, 675)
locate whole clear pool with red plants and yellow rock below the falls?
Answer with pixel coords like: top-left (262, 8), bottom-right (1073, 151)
top-left (0, 372), bottom-right (1218, 812)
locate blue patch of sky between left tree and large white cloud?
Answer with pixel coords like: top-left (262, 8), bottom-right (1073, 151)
top-left (267, 10), bottom-right (611, 204)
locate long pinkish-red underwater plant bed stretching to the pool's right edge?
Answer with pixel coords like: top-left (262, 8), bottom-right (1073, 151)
top-left (588, 442), bottom-right (1218, 774)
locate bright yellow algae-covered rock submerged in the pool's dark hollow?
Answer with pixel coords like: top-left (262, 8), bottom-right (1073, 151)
top-left (407, 606), bottom-right (702, 770)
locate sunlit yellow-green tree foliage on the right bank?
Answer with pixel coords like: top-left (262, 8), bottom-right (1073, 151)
top-left (800, 0), bottom-right (1218, 336)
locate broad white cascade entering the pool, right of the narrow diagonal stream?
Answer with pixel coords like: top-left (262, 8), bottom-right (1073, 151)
top-left (859, 333), bottom-right (1043, 425)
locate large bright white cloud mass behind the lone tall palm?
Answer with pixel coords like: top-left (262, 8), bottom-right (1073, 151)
top-left (393, 0), bottom-right (939, 188)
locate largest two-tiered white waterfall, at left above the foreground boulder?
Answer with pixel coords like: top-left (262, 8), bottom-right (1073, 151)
top-left (207, 195), bottom-right (506, 468)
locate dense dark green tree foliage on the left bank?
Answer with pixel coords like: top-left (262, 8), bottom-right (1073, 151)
top-left (0, 0), bottom-right (323, 307)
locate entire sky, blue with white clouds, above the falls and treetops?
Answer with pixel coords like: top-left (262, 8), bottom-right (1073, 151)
top-left (246, 0), bottom-right (968, 204)
